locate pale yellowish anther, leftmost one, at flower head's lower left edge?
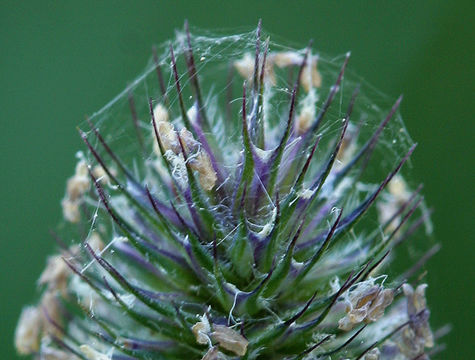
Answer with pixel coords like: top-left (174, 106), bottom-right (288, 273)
top-left (15, 306), bottom-right (43, 355)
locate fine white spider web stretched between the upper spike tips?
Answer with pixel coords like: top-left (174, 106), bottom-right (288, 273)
top-left (77, 23), bottom-right (432, 270)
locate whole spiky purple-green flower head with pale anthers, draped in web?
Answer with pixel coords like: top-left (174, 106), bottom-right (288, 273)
top-left (15, 24), bottom-right (436, 360)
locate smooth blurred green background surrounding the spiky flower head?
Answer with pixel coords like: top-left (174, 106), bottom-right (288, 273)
top-left (0, 0), bottom-right (475, 359)
